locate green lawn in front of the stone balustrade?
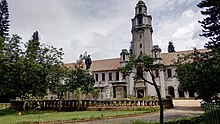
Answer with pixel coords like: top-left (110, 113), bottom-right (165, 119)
top-left (0, 109), bottom-right (153, 124)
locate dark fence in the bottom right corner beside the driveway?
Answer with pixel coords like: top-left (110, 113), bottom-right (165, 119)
top-left (203, 101), bottom-right (220, 124)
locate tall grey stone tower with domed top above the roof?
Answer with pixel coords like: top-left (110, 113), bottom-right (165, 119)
top-left (130, 0), bottom-right (153, 56)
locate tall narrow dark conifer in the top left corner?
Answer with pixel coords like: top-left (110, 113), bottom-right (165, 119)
top-left (0, 0), bottom-right (10, 38)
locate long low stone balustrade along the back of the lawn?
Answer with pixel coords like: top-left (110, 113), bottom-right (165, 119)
top-left (10, 100), bottom-right (173, 111)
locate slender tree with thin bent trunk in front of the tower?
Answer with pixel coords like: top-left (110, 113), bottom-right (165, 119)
top-left (119, 55), bottom-right (163, 124)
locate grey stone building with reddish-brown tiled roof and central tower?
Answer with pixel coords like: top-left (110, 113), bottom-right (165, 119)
top-left (66, 0), bottom-right (206, 99)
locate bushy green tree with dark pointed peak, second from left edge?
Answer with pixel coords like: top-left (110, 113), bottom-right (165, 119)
top-left (24, 31), bottom-right (63, 96)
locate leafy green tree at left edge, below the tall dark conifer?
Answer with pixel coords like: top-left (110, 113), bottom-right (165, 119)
top-left (0, 35), bottom-right (22, 100)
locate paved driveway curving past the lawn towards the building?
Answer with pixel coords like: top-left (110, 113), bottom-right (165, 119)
top-left (70, 100), bottom-right (203, 124)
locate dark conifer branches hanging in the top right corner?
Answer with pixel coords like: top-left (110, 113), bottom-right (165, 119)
top-left (197, 0), bottom-right (220, 49)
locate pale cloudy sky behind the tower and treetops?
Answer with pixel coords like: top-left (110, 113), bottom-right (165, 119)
top-left (8, 0), bottom-right (207, 63)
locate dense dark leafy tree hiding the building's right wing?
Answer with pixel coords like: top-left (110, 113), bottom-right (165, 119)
top-left (176, 50), bottom-right (220, 101)
